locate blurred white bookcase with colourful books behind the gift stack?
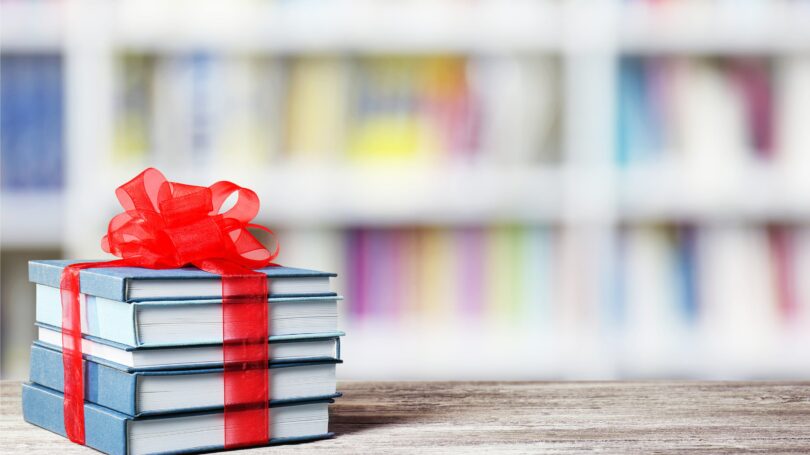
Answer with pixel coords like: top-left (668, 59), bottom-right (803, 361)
top-left (0, 0), bottom-right (810, 379)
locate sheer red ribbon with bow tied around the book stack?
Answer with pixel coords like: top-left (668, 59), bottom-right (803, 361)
top-left (60, 168), bottom-right (278, 448)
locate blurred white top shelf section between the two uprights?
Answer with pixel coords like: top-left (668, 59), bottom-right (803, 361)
top-left (113, 0), bottom-right (561, 53)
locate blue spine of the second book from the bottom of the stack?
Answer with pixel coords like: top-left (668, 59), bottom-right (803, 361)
top-left (31, 345), bottom-right (137, 416)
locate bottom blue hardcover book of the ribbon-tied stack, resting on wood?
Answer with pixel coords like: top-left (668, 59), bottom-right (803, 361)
top-left (22, 383), bottom-right (334, 455)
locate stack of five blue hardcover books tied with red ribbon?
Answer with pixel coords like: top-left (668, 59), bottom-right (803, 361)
top-left (23, 260), bottom-right (343, 455)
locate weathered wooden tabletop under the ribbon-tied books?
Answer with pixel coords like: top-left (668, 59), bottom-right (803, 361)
top-left (0, 382), bottom-right (810, 455)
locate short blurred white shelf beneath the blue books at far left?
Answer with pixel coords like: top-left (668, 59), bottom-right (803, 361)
top-left (0, 191), bottom-right (64, 249)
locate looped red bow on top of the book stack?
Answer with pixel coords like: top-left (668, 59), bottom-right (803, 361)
top-left (101, 168), bottom-right (278, 269)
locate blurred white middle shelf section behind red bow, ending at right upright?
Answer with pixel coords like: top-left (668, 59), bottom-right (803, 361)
top-left (105, 164), bottom-right (562, 226)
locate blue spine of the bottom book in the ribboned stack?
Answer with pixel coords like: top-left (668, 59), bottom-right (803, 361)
top-left (22, 384), bottom-right (127, 455)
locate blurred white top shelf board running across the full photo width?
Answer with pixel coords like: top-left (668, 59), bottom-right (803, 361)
top-left (7, 0), bottom-right (810, 54)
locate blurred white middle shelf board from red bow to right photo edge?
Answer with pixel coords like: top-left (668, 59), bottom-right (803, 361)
top-left (90, 163), bottom-right (810, 227)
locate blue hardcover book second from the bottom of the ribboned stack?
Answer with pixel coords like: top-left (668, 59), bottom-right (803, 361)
top-left (30, 342), bottom-right (340, 416)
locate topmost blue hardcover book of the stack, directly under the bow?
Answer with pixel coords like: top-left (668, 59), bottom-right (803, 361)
top-left (28, 260), bottom-right (337, 302)
